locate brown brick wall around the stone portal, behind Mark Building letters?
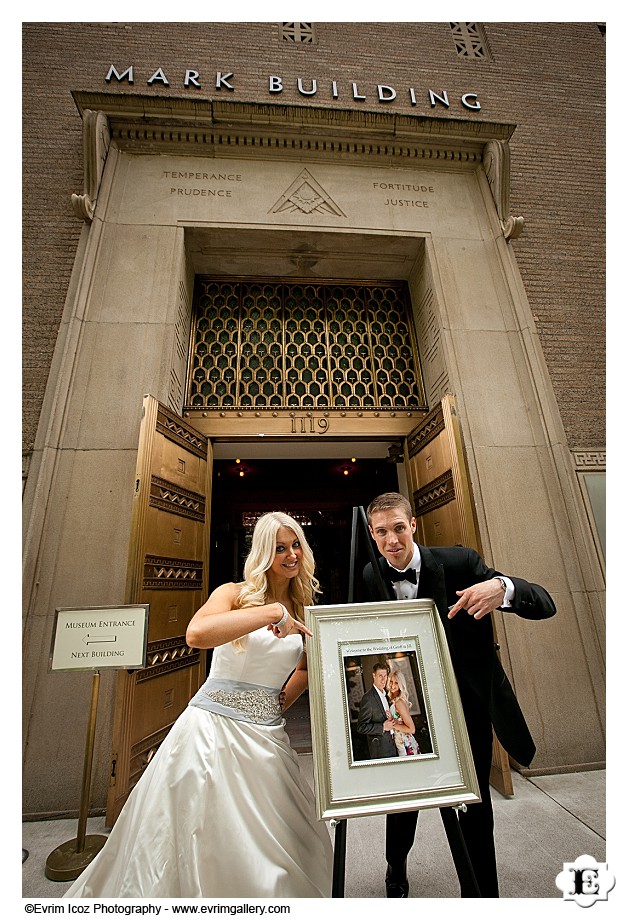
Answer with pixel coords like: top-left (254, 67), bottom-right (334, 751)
top-left (23, 23), bottom-right (605, 449)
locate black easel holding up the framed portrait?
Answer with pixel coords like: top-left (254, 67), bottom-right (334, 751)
top-left (331, 507), bottom-right (481, 898)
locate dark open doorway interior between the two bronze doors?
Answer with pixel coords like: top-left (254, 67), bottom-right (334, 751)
top-left (209, 453), bottom-right (399, 753)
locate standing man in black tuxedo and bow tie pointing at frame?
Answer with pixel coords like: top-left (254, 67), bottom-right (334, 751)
top-left (364, 492), bottom-right (556, 898)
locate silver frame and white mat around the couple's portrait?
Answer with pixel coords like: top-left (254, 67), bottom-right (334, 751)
top-left (305, 600), bottom-right (480, 820)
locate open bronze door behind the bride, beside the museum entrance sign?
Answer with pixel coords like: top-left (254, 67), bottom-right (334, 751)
top-left (107, 396), bottom-right (211, 826)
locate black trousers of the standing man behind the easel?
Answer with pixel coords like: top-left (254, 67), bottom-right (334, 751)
top-left (386, 702), bottom-right (499, 898)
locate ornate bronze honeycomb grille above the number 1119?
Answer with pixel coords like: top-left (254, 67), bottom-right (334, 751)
top-left (185, 277), bottom-right (425, 411)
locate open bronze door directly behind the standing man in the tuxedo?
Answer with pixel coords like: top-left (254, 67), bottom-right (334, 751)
top-left (406, 395), bottom-right (514, 795)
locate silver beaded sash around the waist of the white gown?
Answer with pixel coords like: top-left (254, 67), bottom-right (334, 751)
top-left (188, 677), bottom-right (283, 725)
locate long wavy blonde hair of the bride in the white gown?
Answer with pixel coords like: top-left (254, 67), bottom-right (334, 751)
top-left (236, 511), bottom-right (321, 622)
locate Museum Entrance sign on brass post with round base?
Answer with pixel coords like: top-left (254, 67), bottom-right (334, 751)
top-left (45, 604), bottom-right (149, 882)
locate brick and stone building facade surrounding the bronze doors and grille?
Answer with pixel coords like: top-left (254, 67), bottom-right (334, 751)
top-left (24, 23), bottom-right (604, 814)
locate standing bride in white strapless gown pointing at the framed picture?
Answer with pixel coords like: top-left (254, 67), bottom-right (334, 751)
top-left (64, 512), bottom-right (332, 898)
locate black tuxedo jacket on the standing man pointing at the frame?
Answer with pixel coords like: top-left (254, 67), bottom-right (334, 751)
top-left (364, 546), bottom-right (556, 766)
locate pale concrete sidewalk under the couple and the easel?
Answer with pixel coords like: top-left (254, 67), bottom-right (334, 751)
top-left (22, 754), bottom-right (604, 898)
